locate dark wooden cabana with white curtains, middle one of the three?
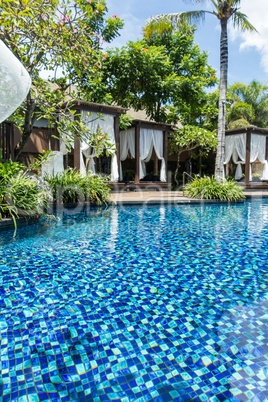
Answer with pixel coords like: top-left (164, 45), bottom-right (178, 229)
top-left (119, 117), bottom-right (172, 189)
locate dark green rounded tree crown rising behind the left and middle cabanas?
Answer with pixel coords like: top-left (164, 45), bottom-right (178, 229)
top-left (95, 40), bottom-right (179, 121)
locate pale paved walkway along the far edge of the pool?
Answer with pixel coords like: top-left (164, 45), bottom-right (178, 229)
top-left (111, 190), bottom-right (268, 204)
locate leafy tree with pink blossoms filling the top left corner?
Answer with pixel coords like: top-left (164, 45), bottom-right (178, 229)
top-left (0, 0), bottom-right (123, 157)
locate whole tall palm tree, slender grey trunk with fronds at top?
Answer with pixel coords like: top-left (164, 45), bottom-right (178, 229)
top-left (144, 0), bottom-right (256, 180)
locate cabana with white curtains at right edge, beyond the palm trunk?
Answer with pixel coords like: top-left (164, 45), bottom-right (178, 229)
top-left (224, 126), bottom-right (268, 188)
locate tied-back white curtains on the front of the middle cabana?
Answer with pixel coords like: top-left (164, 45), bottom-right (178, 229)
top-left (140, 128), bottom-right (167, 182)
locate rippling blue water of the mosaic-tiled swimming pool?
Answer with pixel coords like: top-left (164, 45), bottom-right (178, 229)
top-left (0, 199), bottom-right (268, 402)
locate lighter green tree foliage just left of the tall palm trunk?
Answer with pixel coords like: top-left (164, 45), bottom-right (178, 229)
top-left (144, 27), bottom-right (218, 126)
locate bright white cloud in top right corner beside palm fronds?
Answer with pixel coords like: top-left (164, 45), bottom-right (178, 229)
top-left (230, 0), bottom-right (268, 73)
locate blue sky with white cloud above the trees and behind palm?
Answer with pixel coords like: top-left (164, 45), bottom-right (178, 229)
top-left (106, 0), bottom-right (268, 85)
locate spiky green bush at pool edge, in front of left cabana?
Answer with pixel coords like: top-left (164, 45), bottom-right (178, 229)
top-left (45, 169), bottom-right (111, 204)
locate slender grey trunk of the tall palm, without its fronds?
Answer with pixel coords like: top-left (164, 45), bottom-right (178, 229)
top-left (215, 19), bottom-right (228, 181)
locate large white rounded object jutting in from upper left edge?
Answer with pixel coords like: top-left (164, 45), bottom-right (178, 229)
top-left (0, 40), bottom-right (31, 123)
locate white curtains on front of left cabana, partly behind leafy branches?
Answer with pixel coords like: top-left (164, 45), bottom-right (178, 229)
top-left (80, 110), bottom-right (119, 182)
